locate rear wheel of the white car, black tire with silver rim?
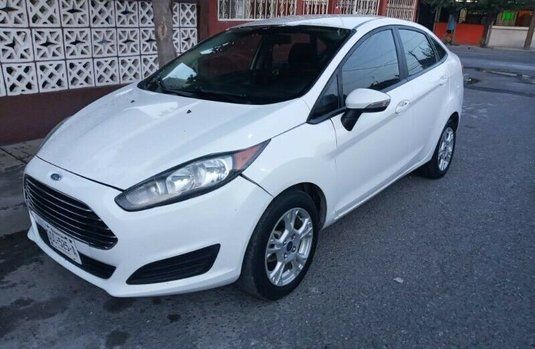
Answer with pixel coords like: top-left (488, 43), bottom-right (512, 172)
top-left (417, 120), bottom-right (457, 179)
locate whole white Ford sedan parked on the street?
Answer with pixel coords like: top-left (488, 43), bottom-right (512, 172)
top-left (24, 16), bottom-right (463, 299)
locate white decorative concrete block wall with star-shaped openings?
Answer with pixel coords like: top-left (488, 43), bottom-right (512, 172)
top-left (0, 0), bottom-right (197, 97)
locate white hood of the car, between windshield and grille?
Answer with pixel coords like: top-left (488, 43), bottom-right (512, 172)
top-left (37, 85), bottom-right (309, 189)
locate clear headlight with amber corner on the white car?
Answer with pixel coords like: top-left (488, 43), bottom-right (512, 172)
top-left (115, 141), bottom-right (269, 211)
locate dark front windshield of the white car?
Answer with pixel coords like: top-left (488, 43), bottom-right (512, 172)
top-left (139, 26), bottom-right (351, 104)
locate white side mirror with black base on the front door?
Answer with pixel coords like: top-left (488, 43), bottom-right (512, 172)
top-left (341, 88), bottom-right (390, 131)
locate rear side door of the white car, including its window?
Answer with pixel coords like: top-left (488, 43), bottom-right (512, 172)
top-left (398, 27), bottom-right (449, 159)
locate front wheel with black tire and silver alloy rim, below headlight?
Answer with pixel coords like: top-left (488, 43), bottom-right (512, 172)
top-left (238, 190), bottom-right (319, 300)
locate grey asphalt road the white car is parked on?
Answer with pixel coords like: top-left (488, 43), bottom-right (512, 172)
top-left (0, 48), bottom-right (535, 348)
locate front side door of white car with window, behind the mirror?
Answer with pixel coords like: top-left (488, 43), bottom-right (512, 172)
top-left (324, 28), bottom-right (414, 216)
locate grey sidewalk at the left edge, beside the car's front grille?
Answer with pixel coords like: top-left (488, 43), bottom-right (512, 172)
top-left (0, 139), bottom-right (42, 236)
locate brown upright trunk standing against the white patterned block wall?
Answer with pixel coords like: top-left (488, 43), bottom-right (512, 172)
top-left (152, 0), bottom-right (176, 67)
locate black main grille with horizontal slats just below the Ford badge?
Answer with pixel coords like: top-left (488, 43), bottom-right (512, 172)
top-left (24, 176), bottom-right (117, 250)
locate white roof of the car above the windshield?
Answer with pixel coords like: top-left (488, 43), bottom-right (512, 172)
top-left (235, 15), bottom-right (385, 29)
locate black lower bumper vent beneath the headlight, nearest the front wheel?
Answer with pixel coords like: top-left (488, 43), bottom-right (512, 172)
top-left (126, 244), bottom-right (220, 285)
